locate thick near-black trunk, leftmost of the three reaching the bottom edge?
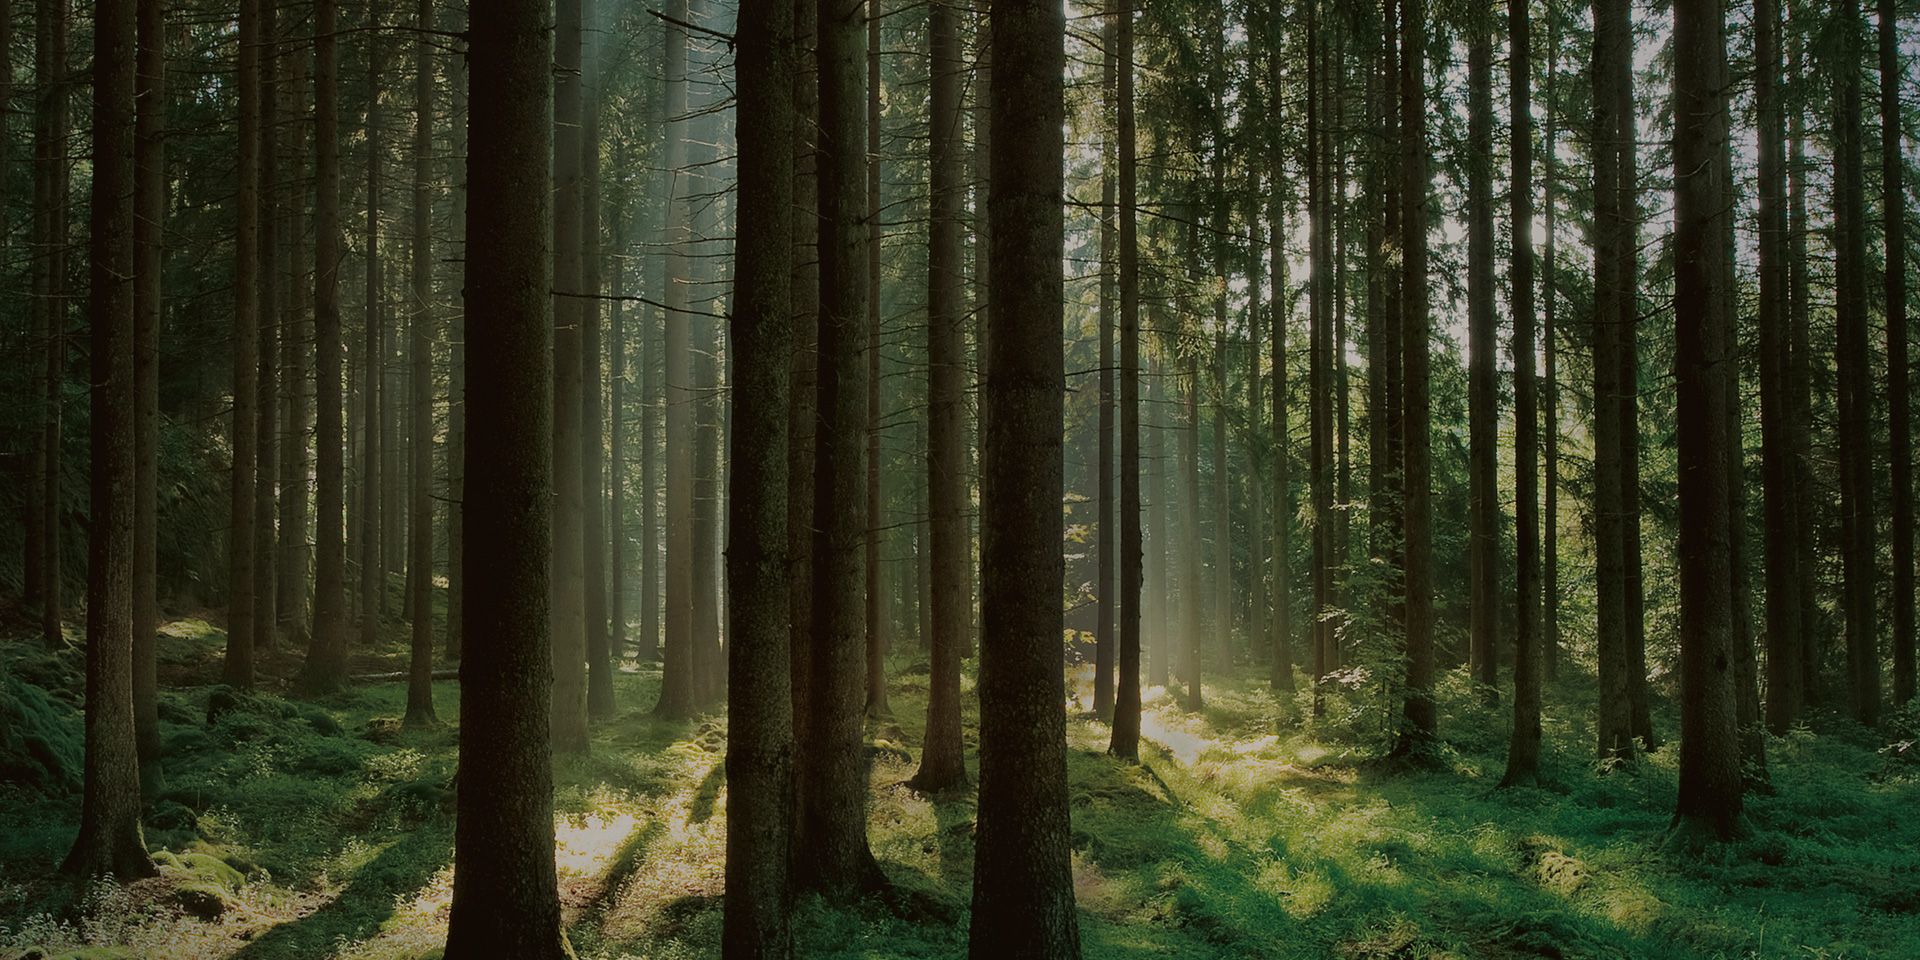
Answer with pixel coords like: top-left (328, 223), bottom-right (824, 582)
top-left (447, 0), bottom-right (572, 948)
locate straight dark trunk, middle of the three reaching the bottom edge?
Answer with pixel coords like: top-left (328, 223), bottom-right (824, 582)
top-left (722, 0), bottom-right (797, 960)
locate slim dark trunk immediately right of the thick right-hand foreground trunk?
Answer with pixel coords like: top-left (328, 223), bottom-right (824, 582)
top-left (1753, 0), bottom-right (1812, 735)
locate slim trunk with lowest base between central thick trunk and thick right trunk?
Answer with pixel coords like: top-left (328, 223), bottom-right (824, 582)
top-left (1500, 0), bottom-right (1540, 787)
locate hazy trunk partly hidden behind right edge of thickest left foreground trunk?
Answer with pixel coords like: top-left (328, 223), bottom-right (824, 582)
top-left (551, 0), bottom-right (588, 753)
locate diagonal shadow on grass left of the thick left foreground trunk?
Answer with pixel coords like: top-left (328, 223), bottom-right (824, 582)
top-left (230, 824), bottom-right (453, 960)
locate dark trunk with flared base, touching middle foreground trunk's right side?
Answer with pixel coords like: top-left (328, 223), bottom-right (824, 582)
top-left (795, 0), bottom-right (881, 902)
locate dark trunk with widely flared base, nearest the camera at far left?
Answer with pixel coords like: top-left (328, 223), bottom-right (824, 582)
top-left (60, 0), bottom-right (155, 883)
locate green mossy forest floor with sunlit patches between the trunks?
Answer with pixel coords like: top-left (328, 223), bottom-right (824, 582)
top-left (0, 606), bottom-right (1920, 960)
